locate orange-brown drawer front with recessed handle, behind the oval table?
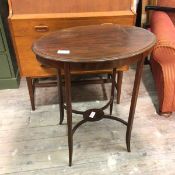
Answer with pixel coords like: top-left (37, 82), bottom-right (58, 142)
top-left (11, 14), bottom-right (135, 37)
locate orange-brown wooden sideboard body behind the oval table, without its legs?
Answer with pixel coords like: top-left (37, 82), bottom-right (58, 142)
top-left (9, 0), bottom-right (135, 77)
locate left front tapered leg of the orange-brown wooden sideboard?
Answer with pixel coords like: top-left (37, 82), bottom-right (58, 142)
top-left (26, 77), bottom-right (35, 111)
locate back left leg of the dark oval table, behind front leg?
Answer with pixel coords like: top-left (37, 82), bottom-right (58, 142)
top-left (57, 69), bottom-right (64, 125)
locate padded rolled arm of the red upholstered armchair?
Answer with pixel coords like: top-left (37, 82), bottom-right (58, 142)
top-left (151, 11), bottom-right (175, 64)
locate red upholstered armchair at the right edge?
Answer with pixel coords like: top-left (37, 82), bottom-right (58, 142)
top-left (146, 0), bottom-right (175, 115)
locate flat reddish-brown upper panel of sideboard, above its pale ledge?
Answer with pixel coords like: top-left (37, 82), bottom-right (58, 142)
top-left (9, 0), bottom-right (132, 14)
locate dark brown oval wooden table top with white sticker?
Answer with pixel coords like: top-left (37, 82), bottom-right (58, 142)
top-left (32, 24), bottom-right (156, 63)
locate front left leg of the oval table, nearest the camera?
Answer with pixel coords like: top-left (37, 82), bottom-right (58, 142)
top-left (64, 64), bottom-right (73, 166)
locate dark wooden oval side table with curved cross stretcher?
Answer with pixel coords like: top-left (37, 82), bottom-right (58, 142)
top-left (32, 24), bottom-right (156, 166)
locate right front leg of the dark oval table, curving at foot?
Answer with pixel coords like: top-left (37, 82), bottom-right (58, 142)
top-left (126, 58), bottom-right (145, 152)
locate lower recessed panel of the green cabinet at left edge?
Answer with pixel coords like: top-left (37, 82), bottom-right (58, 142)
top-left (0, 54), bottom-right (11, 78)
